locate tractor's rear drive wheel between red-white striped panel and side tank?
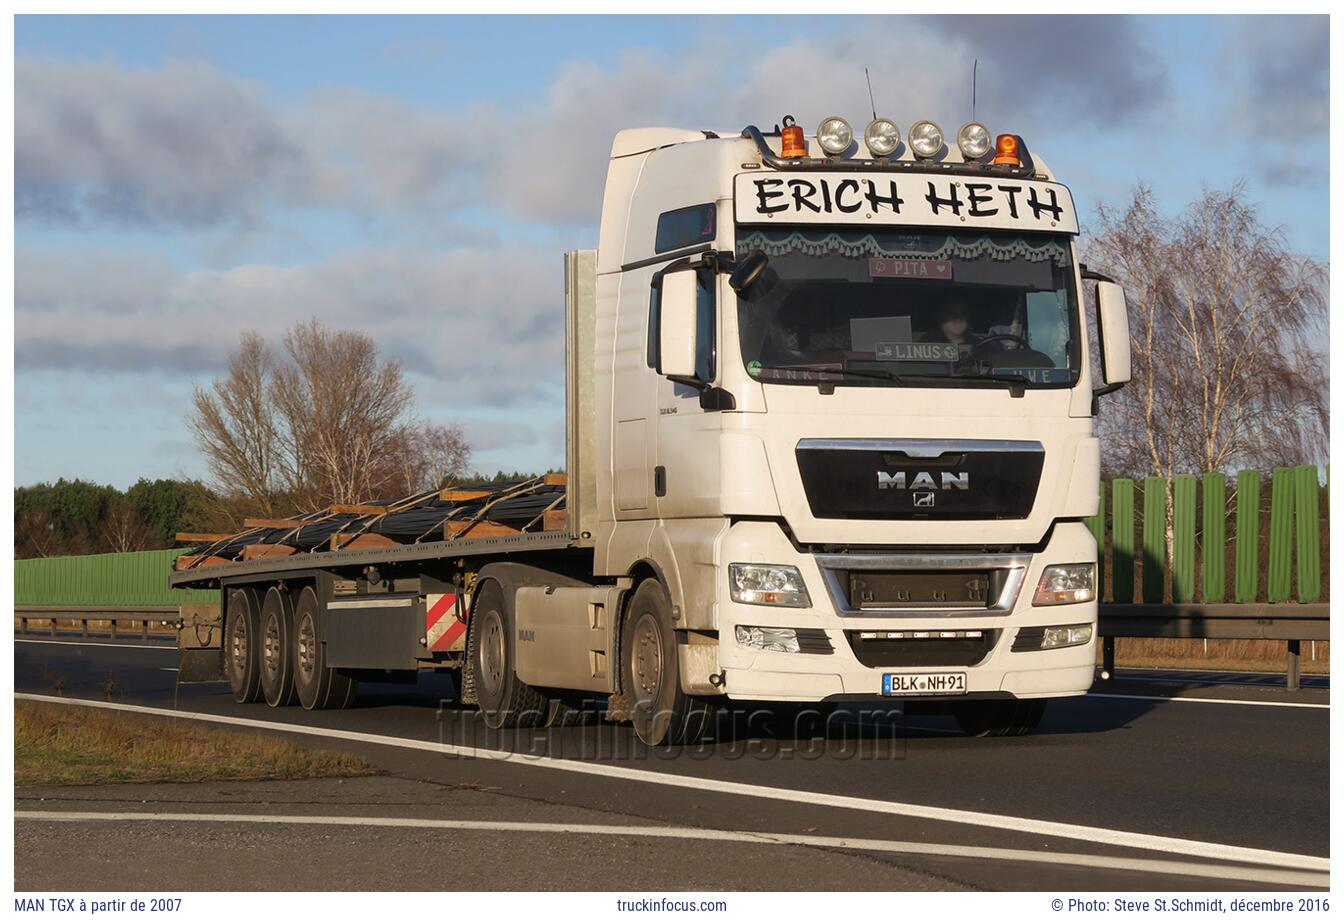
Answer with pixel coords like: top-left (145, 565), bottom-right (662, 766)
top-left (466, 580), bottom-right (550, 728)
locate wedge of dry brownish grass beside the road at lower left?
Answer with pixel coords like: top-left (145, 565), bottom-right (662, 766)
top-left (13, 700), bottom-right (379, 786)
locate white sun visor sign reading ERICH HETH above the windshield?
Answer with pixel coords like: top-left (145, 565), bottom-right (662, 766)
top-left (734, 172), bottom-right (1078, 234)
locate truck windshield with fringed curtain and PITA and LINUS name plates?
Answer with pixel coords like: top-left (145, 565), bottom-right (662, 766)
top-left (737, 227), bottom-right (1079, 387)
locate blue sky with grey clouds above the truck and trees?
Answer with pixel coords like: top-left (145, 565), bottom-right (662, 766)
top-left (15, 15), bottom-right (1329, 488)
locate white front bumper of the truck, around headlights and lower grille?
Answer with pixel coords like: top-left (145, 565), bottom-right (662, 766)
top-left (718, 521), bottom-right (1097, 701)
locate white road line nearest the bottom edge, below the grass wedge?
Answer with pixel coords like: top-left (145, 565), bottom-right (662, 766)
top-left (13, 810), bottom-right (1331, 888)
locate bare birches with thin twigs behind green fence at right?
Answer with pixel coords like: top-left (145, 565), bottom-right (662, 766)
top-left (1085, 185), bottom-right (1329, 477)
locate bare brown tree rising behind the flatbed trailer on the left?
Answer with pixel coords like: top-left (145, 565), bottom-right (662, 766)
top-left (190, 320), bottom-right (470, 516)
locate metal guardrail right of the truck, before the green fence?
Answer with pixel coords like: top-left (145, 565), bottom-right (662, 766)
top-left (1097, 603), bottom-right (1331, 690)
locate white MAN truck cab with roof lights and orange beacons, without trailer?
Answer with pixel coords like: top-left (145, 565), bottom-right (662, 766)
top-left (585, 118), bottom-right (1129, 740)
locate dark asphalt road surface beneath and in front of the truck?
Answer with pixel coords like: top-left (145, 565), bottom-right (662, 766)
top-left (15, 639), bottom-right (1329, 890)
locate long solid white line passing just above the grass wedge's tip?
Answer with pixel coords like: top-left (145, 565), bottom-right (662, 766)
top-left (13, 693), bottom-right (1329, 872)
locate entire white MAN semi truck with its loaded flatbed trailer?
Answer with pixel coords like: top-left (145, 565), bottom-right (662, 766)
top-left (171, 112), bottom-right (1129, 744)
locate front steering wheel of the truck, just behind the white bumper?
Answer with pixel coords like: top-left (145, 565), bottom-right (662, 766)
top-left (621, 579), bottom-right (715, 747)
